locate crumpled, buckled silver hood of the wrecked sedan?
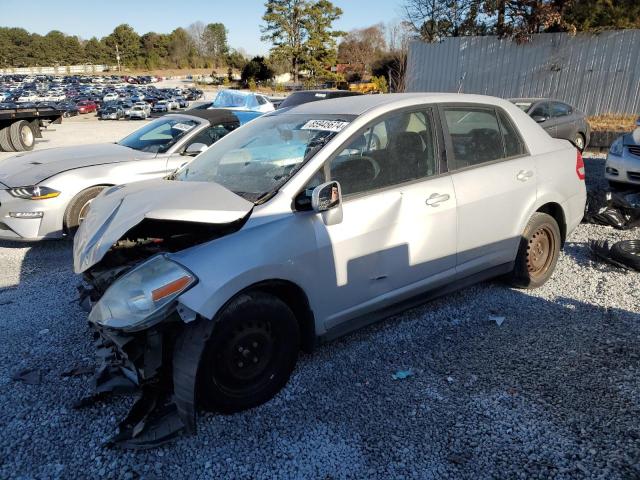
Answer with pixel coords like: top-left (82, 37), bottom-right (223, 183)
top-left (73, 180), bottom-right (253, 273)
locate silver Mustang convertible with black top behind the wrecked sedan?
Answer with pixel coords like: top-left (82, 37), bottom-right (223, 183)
top-left (0, 110), bottom-right (248, 240)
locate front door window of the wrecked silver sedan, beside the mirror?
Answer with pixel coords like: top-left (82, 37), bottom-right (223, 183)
top-left (329, 110), bottom-right (437, 195)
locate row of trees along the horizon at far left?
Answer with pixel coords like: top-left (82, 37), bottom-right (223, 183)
top-left (0, 22), bottom-right (246, 69)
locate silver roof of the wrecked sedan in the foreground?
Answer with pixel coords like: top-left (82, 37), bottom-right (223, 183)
top-left (287, 92), bottom-right (511, 115)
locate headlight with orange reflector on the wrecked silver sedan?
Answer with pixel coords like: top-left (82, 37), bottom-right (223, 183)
top-left (89, 255), bottom-right (197, 331)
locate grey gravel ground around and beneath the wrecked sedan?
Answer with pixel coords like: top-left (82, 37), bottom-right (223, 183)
top-left (0, 159), bottom-right (640, 479)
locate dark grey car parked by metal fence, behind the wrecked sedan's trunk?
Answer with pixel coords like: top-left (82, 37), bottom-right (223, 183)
top-left (511, 98), bottom-right (591, 151)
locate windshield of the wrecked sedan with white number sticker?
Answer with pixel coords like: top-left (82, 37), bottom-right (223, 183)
top-left (175, 114), bottom-right (355, 202)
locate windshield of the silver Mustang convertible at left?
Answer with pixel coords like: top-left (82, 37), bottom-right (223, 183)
top-left (118, 117), bottom-right (199, 153)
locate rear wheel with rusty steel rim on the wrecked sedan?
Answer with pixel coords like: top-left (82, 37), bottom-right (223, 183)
top-left (507, 212), bottom-right (562, 288)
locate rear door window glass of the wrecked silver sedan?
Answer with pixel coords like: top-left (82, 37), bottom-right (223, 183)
top-left (443, 107), bottom-right (504, 168)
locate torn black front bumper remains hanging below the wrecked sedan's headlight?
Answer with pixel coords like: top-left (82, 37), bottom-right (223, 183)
top-left (77, 310), bottom-right (213, 449)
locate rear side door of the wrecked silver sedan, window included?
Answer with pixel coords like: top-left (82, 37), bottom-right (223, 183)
top-left (440, 104), bottom-right (536, 276)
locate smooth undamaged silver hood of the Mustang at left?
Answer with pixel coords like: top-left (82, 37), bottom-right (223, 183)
top-left (0, 143), bottom-right (155, 187)
